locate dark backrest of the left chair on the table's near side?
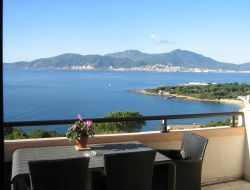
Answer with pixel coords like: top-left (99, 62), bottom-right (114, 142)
top-left (28, 157), bottom-right (89, 190)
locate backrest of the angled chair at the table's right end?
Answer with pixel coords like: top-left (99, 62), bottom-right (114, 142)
top-left (181, 131), bottom-right (208, 161)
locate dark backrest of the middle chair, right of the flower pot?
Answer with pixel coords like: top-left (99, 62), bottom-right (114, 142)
top-left (104, 150), bottom-right (156, 190)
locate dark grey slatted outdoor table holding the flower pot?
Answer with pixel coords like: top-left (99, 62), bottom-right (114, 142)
top-left (11, 141), bottom-right (174, 190)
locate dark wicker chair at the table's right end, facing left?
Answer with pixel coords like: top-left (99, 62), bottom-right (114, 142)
top-left (154, 132), bottom-right (208, 190)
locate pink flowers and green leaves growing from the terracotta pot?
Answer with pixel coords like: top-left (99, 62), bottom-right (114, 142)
top-left (66, 114), bottom-right (95, 140)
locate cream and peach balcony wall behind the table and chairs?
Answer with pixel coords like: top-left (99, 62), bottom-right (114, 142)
top-left (4, 111), bottom-right (250, 190)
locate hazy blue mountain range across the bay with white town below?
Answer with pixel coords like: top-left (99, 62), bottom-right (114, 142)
top-left (4, 49), bottom-right (250, 71)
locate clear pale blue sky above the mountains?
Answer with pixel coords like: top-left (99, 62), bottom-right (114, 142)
top-left (3, 0), bottom-right (250, 64)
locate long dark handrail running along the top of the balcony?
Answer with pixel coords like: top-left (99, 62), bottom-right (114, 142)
top-left (3, 112), bottom-right (244, 127)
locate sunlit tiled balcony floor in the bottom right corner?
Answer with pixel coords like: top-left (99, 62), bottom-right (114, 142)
top-left (201, 180), bottom-right (250, 190)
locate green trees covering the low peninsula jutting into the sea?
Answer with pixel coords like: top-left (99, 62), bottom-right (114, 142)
top-left (146, 83), bottom-right (250, 100)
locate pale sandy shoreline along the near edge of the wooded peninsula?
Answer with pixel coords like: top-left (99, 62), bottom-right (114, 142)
top-left (133, 89), bottom-right (245, 109)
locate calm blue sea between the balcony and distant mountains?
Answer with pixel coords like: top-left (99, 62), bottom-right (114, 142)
top-left (4, 69), bottom-right (250, 132)
